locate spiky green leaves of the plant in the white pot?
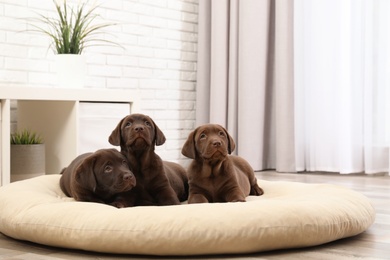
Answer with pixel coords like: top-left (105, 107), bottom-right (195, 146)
top-left (31, 0), bottom-right (119, 54)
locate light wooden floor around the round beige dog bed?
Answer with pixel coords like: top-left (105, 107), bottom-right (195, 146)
top-left (0, 171), bottom-right (390, 260)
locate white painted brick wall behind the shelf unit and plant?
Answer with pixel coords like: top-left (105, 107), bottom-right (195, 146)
top-left (0, 0), bottom-right (198, 164)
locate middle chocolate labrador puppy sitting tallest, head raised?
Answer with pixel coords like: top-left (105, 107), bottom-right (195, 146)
top-left (108, 114), bottom-right (188, 206)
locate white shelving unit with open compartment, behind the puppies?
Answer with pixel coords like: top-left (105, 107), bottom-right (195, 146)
top-left (0, 87), bottom-right (139, 186)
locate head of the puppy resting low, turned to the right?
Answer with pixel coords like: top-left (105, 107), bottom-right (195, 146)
top-left (75, 149), bottom-right (136, 199)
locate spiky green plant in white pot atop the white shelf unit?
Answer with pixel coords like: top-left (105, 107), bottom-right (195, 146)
top-left (32, 0), bottom-right (119, 88)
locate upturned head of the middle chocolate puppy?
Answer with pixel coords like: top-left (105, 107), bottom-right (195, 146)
top-left (108, 114), bottom-right (165, 150)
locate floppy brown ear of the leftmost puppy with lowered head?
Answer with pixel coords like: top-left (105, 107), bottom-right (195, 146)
top-left (74, 155), bottom-right (97, 196)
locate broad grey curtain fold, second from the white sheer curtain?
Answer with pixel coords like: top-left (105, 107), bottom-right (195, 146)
top-left (236, 0), bottom-right (275, 169)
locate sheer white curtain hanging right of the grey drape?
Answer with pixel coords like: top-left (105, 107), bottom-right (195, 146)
top-left (294, 0), bottom-right (390, 174)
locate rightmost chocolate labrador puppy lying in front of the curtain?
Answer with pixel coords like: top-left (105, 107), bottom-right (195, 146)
top-left (182, 124), bottom-right (264, 203)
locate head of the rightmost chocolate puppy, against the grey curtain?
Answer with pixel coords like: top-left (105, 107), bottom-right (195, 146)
top-left (181, 124), bottom-right (236, 160)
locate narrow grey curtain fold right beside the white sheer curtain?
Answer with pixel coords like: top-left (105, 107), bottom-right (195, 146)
top-left (273, 1), bottom-right (296, 172)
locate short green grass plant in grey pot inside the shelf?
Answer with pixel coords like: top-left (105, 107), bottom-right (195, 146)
top-left (11, 129), bottom-right (46, 182)
